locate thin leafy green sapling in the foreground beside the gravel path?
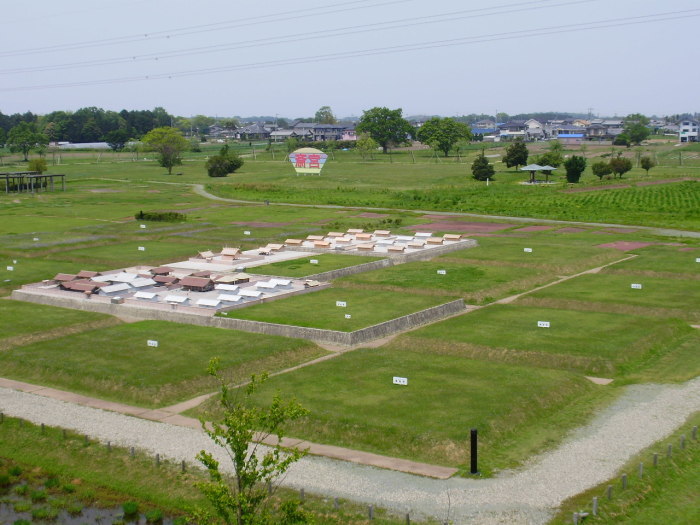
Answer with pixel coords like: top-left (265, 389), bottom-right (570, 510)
top-left (196, 358), bottom-right (309, 525)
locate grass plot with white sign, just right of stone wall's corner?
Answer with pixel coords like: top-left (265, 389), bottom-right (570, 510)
top-left (391, 305), bottom-right (694, 375)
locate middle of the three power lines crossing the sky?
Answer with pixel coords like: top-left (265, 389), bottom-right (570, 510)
top-left (0, 0), bottom-right (600, 75)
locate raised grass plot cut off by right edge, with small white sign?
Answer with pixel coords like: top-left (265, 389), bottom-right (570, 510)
top-left (529, 273), bottom-right (700, 321)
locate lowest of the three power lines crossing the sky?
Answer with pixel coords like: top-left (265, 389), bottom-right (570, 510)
top-left (0, 9), bottom-right (700, 92)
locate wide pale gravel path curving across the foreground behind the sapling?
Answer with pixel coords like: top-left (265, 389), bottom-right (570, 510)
top-left (0, 378), bottom-right (700, 525)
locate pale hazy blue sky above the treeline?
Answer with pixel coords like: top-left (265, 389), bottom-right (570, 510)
top-left (0, 0), bottom-right (700, 118)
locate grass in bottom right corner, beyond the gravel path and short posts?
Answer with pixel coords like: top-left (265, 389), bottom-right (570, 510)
top-left (550, 415), bottom-right (700, 525)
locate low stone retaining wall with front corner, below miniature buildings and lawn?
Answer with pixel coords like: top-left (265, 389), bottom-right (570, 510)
top-left (12, 290), bottom-right (466, 346)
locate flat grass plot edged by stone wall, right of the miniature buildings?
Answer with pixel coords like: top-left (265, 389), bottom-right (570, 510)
top-left (228, 288), bottom-right (453, 332)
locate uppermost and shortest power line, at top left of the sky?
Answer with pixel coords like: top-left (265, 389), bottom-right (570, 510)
top-left (0, 0), bottom-right (414, 57)
